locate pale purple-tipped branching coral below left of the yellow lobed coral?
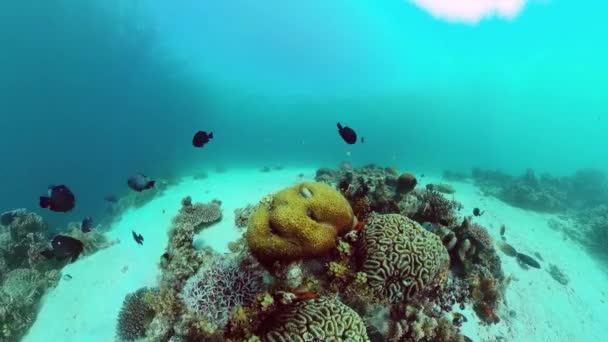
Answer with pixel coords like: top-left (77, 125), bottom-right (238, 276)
top-left (179, 256), bottom-right (263, 326)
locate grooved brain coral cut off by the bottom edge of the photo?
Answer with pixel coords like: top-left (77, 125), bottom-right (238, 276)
top-left (263, 297), bottom-right (369, 342)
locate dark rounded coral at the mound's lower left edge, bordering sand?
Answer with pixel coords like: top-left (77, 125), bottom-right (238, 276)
top-left (116, 287), bottom-right (158, 341)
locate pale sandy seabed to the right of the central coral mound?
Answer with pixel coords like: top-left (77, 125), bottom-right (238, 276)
top-left (424, 177), bottom-right (608, 342)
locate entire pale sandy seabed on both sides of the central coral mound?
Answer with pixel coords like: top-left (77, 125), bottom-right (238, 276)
top-left (24, 168), bottom-right (608, 342)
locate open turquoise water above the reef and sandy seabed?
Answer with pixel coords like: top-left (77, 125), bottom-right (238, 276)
top-left (0, 0), bottom-right (608, 340)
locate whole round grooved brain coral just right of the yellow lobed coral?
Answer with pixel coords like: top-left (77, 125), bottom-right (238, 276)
top-left (357, 214), bottom-right (449, 303)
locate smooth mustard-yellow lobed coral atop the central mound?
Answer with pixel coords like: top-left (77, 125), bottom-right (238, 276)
top-left (245, 182), bottom-right (354, 264)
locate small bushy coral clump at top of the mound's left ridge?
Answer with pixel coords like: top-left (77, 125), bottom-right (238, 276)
top-left (173, 196), bottom-right (222, 229)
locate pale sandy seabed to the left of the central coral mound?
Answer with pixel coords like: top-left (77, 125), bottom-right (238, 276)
top-left (23, 168), bottom-right (315, 342)
